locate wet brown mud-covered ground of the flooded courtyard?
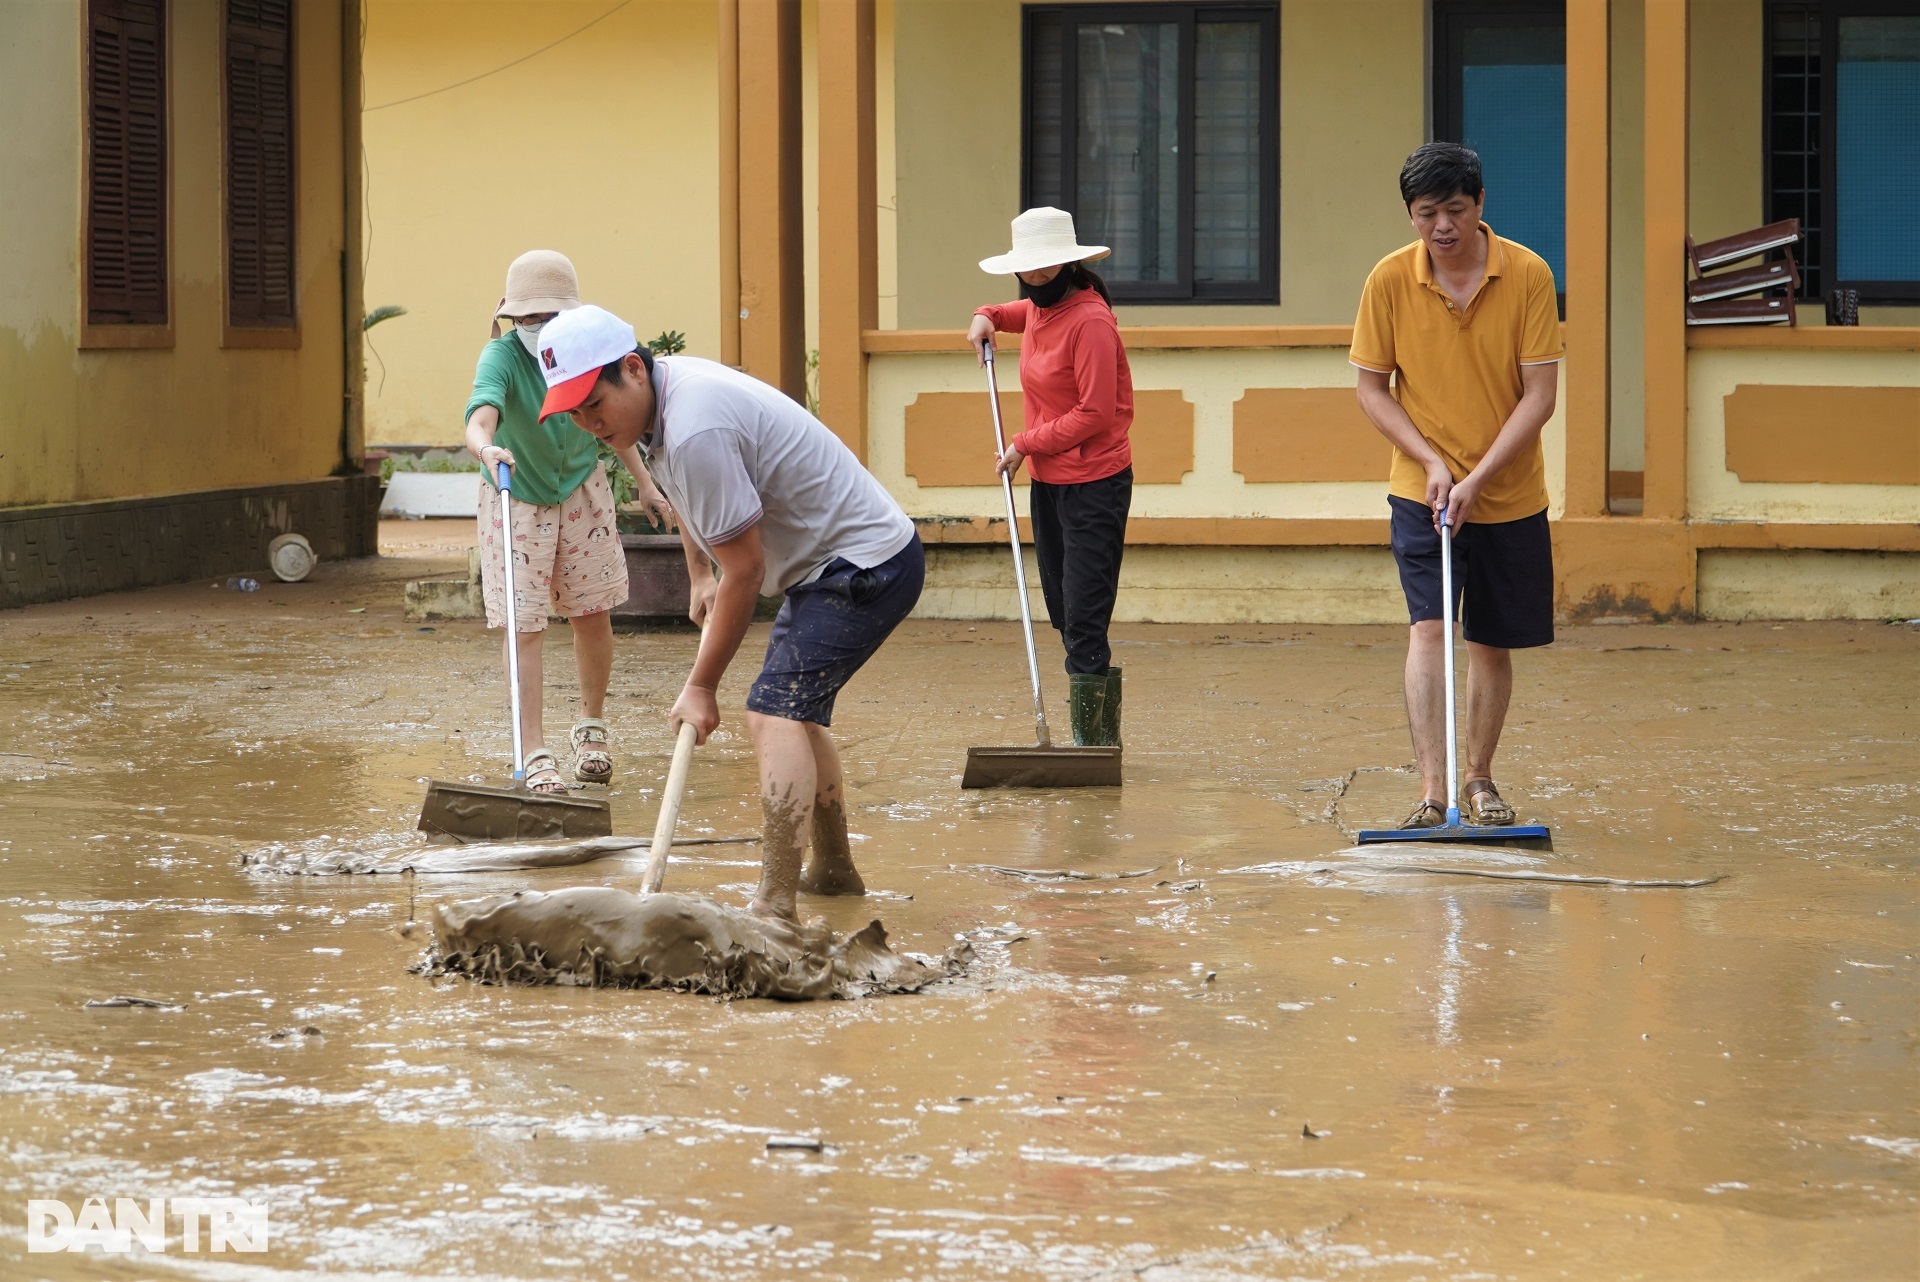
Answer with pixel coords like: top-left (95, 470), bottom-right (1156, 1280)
top-left (0, 562), bottom-right (1920, 1280)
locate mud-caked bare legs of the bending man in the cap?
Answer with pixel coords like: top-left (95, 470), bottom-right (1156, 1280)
top-left (747, 712), bottom-right (866, 921)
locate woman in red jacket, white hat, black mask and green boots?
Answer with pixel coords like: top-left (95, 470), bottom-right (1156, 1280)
top-left (968, 209), bottom-right (1133, 745)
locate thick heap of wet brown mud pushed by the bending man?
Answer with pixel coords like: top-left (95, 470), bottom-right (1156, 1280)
top-left (415, 887), bottom-right (973, 1002)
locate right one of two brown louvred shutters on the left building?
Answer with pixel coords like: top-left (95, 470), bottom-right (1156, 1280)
top-left (227, 0), bottom-right (298, 330)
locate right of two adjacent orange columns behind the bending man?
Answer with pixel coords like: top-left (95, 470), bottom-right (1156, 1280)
top-left (818, 0), bottom-right (879, 463)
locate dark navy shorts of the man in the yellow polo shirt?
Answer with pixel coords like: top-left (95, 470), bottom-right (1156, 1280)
top-left (1386, 495), bottom-right (1553, 651)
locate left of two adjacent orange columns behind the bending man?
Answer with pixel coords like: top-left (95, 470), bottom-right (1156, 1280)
top-left (735, 0), bottom-right (806, 405)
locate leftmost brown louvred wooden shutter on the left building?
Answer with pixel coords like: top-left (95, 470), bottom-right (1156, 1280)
top-left (86, 0), bottom-right (167, 324)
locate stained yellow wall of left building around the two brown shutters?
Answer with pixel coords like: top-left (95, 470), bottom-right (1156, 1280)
top-left (0, 0), bottom-right (346, 507)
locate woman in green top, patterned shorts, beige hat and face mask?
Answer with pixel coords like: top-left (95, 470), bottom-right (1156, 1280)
top-left (467, 249), bottom-right (668, 793)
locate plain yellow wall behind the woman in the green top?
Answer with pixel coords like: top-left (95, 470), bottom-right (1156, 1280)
top-left (363, 0), bottom-right (720, 445)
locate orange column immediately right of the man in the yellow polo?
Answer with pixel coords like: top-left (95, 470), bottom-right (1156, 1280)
top-left (1563, 0), bottom-right (1613, 516)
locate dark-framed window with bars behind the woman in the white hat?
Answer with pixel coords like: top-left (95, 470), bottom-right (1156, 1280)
top-left (1021, 4), bottom-right (1279, 303)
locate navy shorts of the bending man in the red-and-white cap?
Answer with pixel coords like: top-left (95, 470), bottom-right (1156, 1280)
top-left (747, 534), bottom-right (927, 725)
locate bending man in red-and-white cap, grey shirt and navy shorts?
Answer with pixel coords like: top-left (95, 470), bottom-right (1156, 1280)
top-left (540, 307), bottom-right (925, 921)
